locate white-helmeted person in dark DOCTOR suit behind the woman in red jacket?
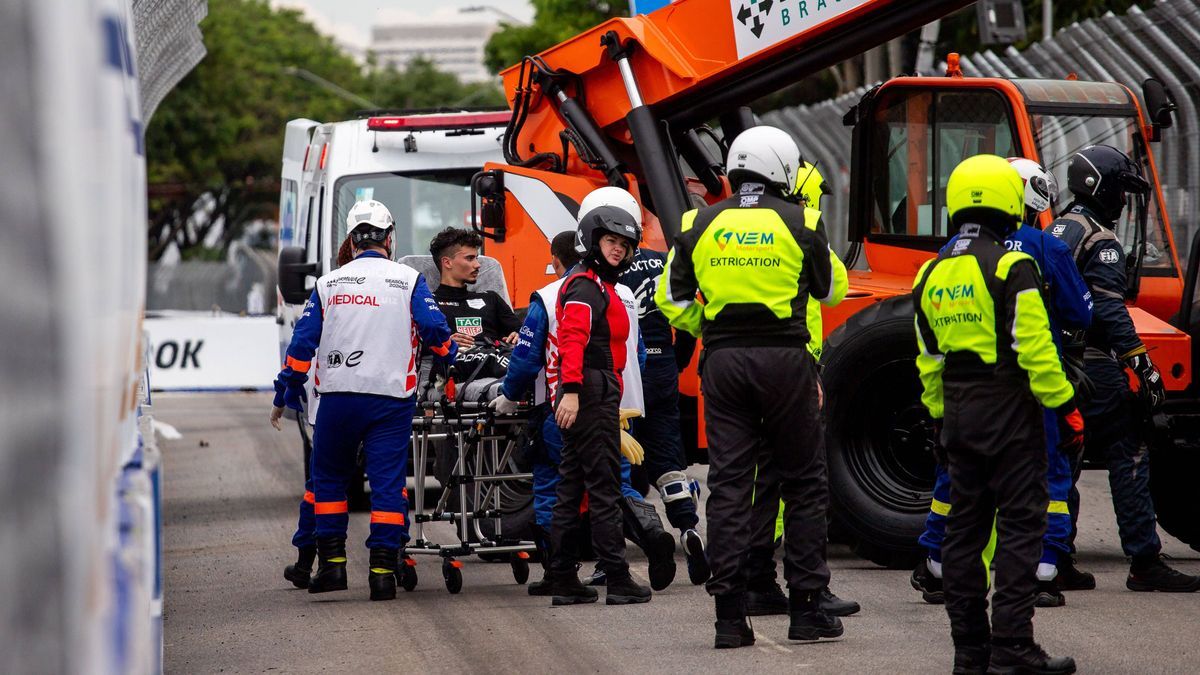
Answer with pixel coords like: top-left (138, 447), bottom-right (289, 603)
top-left (614, 187), bottom-right (709, 585)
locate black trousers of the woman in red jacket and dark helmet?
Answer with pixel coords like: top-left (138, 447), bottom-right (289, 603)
top-left (550, 369), bottom-right (629, 577)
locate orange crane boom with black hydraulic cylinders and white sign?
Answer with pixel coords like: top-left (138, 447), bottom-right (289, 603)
top-left (502, 0), bottom-right (971, 233)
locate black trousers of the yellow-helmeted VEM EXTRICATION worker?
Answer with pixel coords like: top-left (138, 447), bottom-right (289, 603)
top-left (942, 378), bottom-right (1050, 644)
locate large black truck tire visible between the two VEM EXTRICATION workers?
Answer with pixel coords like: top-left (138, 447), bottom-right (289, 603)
top-left (821, 295), bottom-right (935, 568)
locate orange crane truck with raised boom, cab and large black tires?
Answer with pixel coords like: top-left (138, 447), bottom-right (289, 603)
top-left (472, 0), bottom-right (1200, 566)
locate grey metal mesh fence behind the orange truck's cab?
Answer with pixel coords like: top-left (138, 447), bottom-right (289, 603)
top-left (763, 0), bottom-right (1200, 261)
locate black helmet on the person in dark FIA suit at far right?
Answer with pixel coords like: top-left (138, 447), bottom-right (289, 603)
top-left (1067, 145), bottom-right (1150, 222)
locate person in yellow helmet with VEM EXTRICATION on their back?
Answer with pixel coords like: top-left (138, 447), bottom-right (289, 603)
top-left (912, 155), bottom-right (1082, 673)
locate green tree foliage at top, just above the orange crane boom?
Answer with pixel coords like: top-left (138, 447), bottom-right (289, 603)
top-left (484, 0), bottom-right (629, 73)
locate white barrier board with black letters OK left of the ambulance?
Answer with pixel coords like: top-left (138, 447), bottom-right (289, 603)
top-left (144, 315), bottom-right (280, 392)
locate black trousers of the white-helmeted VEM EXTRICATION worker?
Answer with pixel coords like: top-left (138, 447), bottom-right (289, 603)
top-left (701, 346), bottom-right (829, 596)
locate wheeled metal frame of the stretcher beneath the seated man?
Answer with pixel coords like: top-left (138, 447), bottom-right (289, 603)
top-left (400, 396), bottom-right (536, 593)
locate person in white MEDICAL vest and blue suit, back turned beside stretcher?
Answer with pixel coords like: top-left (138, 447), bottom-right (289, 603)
top-left (271, 199), bottom-right (457, 599)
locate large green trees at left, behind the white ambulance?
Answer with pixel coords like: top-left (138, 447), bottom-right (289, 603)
top-left (146, 0), bottom-right (503, 259)
